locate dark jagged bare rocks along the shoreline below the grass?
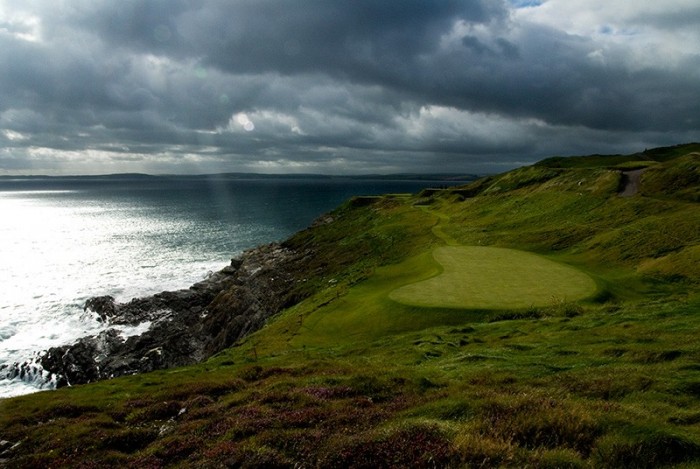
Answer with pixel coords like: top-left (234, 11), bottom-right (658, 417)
top-left (40, 244), bottom-right (308, 386)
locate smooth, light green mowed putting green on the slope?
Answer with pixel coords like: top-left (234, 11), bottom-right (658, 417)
top-left (389, 246), bottom-right (597, 309)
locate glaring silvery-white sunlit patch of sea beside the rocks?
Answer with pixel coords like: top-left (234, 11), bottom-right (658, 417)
top-left (0, 186), bottom-right (235, 397)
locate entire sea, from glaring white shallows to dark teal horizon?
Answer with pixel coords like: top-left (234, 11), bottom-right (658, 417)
top-left (0, 176), bottom-right (454, 397)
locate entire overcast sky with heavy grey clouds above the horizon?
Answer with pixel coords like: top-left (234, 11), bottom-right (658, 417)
top-left (0, 0), bottom-right (700, 175)
